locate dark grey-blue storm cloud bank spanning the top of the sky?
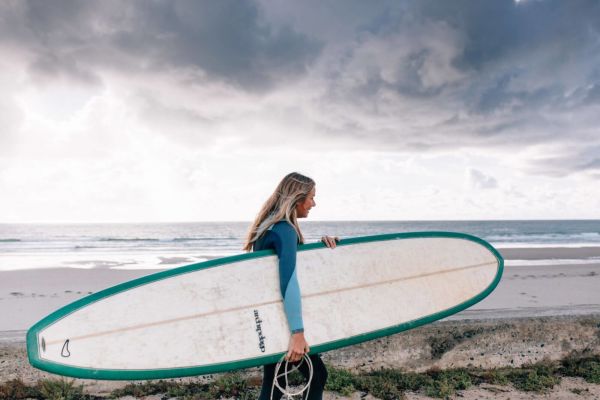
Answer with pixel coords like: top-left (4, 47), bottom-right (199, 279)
top-left (0, 0), bottom-right (600, 176)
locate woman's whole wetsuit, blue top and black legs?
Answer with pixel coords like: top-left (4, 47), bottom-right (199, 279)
top-left (253, 221), bottom-right (327, 400)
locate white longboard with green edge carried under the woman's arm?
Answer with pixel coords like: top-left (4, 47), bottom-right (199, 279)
top-left (27, 232), bottom-right (503, 380)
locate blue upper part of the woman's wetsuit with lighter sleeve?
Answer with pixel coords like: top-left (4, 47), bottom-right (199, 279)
top-left (253, 221), bottom-right (304, 333)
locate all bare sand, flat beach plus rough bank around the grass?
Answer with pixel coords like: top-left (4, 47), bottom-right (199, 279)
top-left (0, 247), bottom-right (600, 399)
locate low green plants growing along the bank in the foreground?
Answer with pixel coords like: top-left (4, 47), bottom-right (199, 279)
top-left (0, 355), bottom-right (600, 400)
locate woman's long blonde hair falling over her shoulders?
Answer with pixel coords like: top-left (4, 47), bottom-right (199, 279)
top-left (243, 172), bottom-right (315, 251)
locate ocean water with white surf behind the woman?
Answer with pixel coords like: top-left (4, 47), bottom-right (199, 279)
top-left (0, 220), bottom-right (600, 271)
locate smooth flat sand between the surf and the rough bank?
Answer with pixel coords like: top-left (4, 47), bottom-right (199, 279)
top-left (0, 247), bottom-right (600, 337)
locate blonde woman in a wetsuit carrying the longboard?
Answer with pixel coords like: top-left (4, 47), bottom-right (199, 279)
top-left (244, 172), bottom-right (338, 400)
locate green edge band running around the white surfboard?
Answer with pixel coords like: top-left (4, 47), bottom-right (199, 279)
top-left (27, 231), bottom-right (504, 380)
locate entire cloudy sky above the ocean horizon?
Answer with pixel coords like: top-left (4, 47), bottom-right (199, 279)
top-left (0, 0), bottom-right (600, 223)
